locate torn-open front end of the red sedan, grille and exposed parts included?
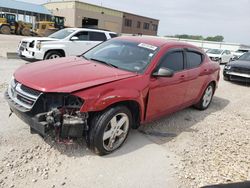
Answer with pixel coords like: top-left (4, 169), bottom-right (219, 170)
top-left (5, 79), bottom-right (88, 139)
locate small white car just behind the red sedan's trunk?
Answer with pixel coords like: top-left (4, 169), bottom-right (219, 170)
top-left (206, 49), bottom-right (233, 64)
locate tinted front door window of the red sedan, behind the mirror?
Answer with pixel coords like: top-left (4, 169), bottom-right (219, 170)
top-left (160, 51), bottom-right (184, 72)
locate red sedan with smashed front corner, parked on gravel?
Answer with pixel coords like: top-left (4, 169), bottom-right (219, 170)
top-left (5, 37), bottom-right (220, 155)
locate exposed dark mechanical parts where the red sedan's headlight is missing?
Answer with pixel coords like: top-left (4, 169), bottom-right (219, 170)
top-left (32, 94), bottom-right (88, 140)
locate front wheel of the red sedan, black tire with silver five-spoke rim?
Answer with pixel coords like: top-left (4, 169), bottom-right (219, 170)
top-left (86, 106), bottom-right (133, 155)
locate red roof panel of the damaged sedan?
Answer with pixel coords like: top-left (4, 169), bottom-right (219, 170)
top-left (113, 36), bottom-right (201, 51)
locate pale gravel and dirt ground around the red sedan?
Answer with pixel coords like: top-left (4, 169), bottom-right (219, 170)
top-left (0, 58), bottom-right (250, 188)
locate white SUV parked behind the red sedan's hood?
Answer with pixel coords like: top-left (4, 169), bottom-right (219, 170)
top-left (18, 28), bottom-right (117, 60)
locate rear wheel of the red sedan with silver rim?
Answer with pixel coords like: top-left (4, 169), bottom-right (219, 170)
top-left (195, 83), bottom-right (215, 110)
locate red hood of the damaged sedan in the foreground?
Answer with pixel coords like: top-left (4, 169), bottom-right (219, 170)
top-left (14, 57), bottom-right (137, 93)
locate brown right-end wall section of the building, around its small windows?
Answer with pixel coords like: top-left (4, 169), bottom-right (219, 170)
top-left (122, 13), bottom-right (159, 36)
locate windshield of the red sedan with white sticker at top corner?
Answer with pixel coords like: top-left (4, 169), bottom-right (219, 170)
top-left (83, 40), bottom-right (158, 73)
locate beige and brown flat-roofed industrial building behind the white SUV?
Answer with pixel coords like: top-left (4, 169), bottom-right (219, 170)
top-left (44, 1), bottom-right (159, 35)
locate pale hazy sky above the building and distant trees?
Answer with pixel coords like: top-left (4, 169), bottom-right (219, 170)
top-left (21, 0), bottom-right (250, 45)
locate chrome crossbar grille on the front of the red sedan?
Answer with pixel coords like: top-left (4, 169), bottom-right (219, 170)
top-left (6, 80), bottom-right (42, 112)
